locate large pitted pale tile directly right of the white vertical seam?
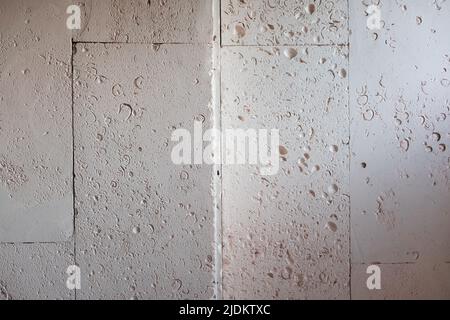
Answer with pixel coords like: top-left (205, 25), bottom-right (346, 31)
top-left (221, 47), bottom-right (349, 299)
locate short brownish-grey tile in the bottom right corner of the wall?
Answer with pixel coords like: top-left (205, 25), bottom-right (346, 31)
top-left (352, 263), bottom-right (450, 300)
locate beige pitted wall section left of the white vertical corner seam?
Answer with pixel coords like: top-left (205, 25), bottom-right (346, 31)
top-left (0, 0), bottom-right (217, 299)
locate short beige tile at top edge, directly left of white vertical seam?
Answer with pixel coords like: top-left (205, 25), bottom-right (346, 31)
top-left (74, 0), bottom-right (213, 43)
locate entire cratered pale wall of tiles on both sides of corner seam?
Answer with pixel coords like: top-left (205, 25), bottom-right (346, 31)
top-left (0, 0), bottom-right (450, 299)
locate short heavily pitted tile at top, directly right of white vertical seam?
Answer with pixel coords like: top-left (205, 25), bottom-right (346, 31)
top-left (221, 0), bottom-right (348, 45)
